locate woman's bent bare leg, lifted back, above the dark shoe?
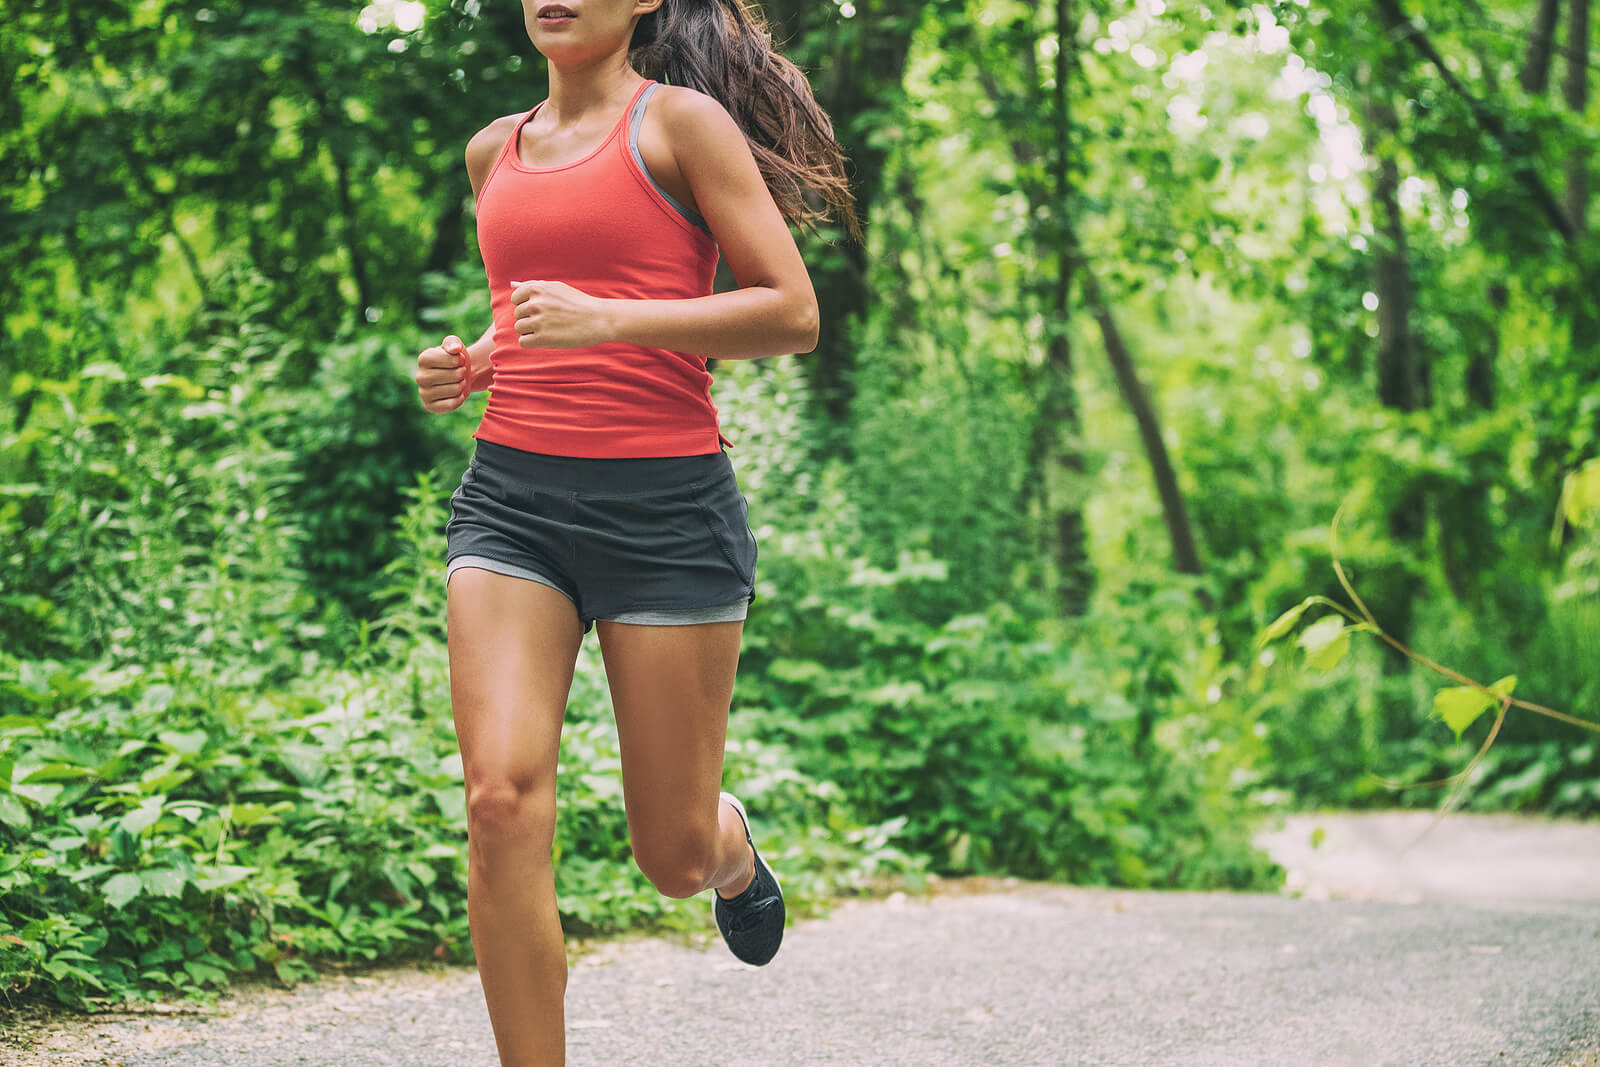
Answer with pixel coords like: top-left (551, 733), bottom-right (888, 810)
top-left (598, 622), bottom-right (755, 897)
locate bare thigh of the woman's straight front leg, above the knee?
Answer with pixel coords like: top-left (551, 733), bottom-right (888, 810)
top-left (446, 566), bottom-right (582, 814)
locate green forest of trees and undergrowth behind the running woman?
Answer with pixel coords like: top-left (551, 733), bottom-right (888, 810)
top-left (0, 0), bottom-right (1600, 1006)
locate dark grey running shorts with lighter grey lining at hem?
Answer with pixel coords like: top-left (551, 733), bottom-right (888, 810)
top-left (445, 438), bottom-right (757, 632)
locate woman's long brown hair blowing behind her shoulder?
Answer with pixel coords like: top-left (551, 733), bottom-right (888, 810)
top-left (629, 0), bottom-right (861, 240)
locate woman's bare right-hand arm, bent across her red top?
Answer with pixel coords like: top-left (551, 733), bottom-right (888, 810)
top-left (512, 86), bottom-right (818, 360)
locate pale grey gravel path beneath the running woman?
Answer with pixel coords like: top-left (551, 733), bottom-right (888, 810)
top-left (9, 814), bottom-right (1600, 1067)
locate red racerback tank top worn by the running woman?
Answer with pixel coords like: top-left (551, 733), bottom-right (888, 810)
top-left (474, 82), bottom-right (722, 459)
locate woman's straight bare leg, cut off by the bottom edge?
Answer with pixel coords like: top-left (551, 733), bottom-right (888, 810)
top-left (448, 568), bottom-right (582, 1067)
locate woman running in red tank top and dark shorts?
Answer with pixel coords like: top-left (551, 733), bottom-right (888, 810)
top-left (416, 0), bottom-right (856, 1067)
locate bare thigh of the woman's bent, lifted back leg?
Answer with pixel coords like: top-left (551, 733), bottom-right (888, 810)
top-left (598, 621), bottom-right (744, 854)
